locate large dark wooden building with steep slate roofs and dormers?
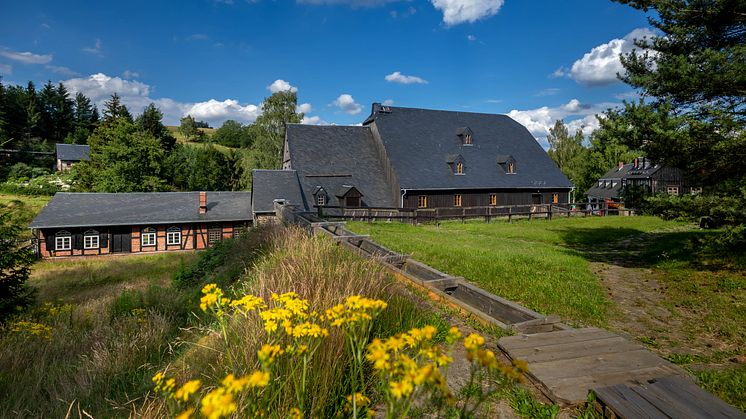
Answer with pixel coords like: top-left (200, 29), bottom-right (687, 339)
top-left (252, 103), bottom-right (572, 215)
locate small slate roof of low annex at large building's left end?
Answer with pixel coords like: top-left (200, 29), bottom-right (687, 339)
top-left (251, 169), bottom-right (306, 213)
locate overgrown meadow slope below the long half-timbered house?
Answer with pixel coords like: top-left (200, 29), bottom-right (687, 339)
top-left (0, 232), bottom-right (266, 417)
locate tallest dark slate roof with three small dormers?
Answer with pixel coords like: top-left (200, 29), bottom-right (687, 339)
top-left (366, 105), bottom-right (572, 189)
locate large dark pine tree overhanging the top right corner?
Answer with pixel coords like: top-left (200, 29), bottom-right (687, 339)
top-left (602, 0), bottom-right (746, 190)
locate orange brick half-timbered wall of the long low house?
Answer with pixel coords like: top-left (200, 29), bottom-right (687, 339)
top-left (36, 221), bottom-right (250, 258)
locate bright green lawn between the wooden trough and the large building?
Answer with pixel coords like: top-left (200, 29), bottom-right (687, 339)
top-left (350, 217), bottom-right (678, 326)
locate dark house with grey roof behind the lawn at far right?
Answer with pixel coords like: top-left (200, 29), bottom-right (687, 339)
top-left (585, 157), bottom-right (702, 202)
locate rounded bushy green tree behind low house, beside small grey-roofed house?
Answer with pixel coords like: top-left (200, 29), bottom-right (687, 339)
top-left (73, 117), bottom-right (171, 192)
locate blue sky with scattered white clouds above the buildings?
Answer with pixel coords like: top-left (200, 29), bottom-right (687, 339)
top-left (0, 0), bottom-right (651, 146)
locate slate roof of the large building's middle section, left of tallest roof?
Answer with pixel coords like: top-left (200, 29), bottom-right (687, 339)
top-left (287, 124), bottom-right (396, 210)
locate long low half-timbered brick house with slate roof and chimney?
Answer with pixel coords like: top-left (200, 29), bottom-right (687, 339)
top-left (29, 192), bottom-right (253, 258)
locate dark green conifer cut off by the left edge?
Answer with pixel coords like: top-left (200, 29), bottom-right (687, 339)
top-left (0, 211), bottom-right (34, 321)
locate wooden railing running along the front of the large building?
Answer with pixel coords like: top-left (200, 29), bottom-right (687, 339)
top-left (314, 202), bottom-right (635, 224)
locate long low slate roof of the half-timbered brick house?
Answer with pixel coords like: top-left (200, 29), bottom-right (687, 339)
top-left (29, 192), bottom-right (253, 228)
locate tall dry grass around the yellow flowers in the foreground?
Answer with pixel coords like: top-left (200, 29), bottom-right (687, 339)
top-left (147, 228), bottom-right (447, 417)
